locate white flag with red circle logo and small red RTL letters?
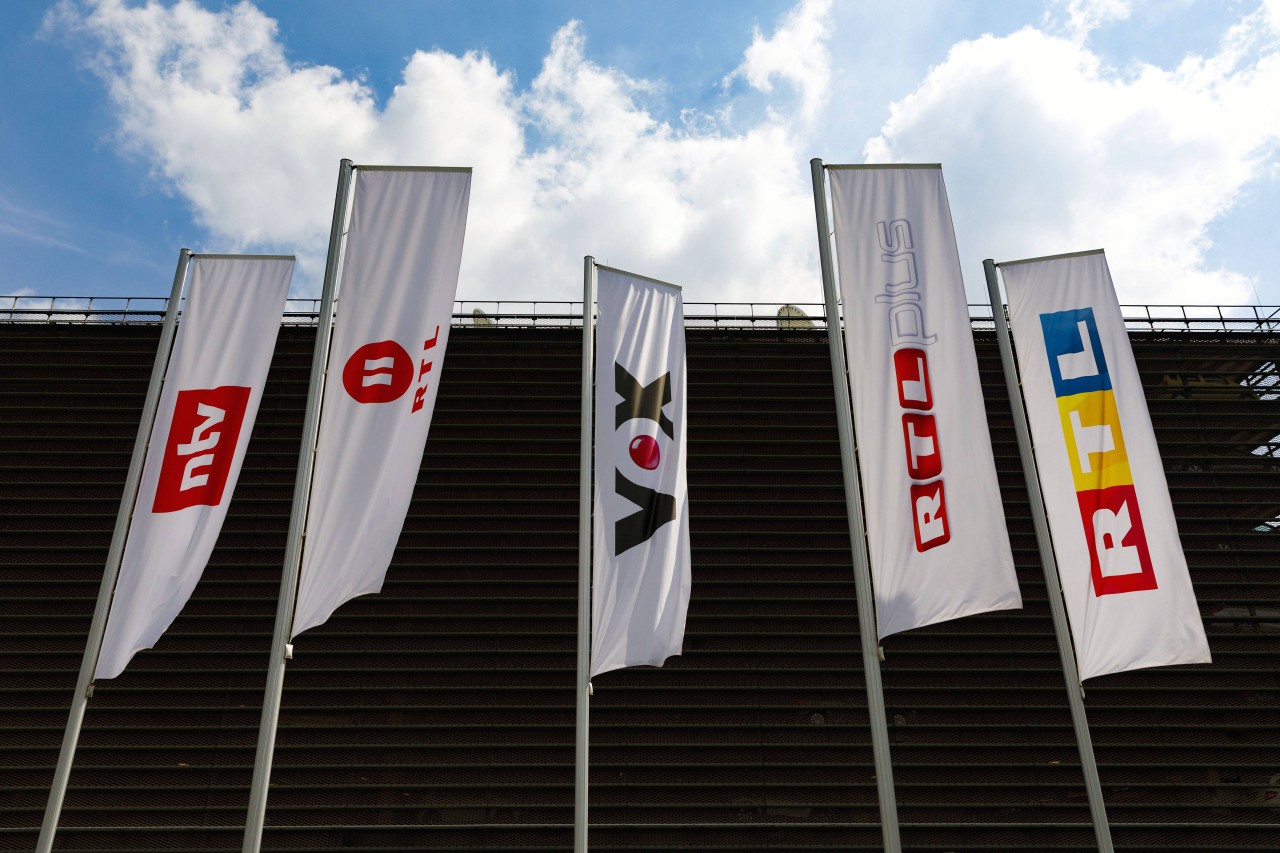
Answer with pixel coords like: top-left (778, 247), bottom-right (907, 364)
top-left (292, 167), bottom-right (471, 637)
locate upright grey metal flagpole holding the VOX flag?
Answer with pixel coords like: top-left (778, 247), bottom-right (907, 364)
top-left (573, 255), bottom-right (595, 853)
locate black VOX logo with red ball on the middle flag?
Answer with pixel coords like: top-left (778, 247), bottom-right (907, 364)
top-left (613, 362), bottom-right (676, 556)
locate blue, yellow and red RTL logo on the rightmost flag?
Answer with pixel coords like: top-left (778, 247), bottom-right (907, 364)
top-left (1041, 309), bottom-right (1156, 596)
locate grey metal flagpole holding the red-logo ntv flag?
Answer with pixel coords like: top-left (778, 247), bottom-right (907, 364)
top-left (36, 248), bottom-right (192, 853)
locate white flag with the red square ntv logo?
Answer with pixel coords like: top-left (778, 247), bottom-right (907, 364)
top-left (93, 255), bottom-right (293, 679)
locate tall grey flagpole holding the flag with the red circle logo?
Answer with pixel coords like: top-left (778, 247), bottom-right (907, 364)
top-left (242, 160), bottom-right (353, 853)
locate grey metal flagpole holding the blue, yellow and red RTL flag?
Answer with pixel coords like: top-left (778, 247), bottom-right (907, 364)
top-left (982, 257), bottom-right (1115, 853)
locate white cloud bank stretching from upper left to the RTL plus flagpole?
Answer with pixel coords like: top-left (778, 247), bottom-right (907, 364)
top-left (50, 0), bottom-right (828, 302)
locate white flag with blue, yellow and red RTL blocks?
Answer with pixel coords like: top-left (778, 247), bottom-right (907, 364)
top-left (1000, 251), bottom-right (1210, 679)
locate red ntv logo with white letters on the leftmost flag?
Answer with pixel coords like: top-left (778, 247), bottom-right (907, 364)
top-left (151, 386), bottom-right (250, 512)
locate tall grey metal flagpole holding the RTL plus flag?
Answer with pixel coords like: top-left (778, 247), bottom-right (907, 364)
top-left (809, 158), bottom-right (902, 853)
